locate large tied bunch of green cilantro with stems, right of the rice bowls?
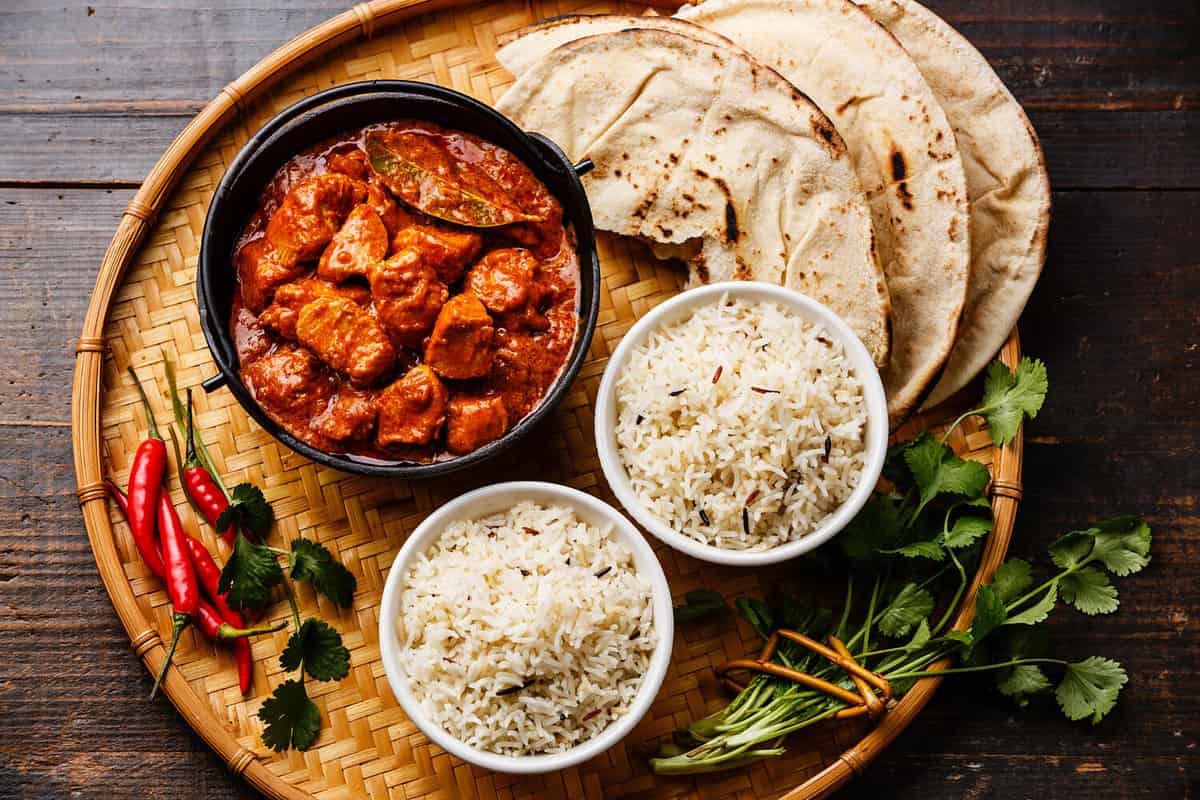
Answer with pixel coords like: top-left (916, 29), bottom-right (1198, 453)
top-left (652, 359), bottom-right (1151, 774)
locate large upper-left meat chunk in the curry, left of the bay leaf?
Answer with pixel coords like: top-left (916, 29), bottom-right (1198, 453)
top-left (266, 173), bottom-right (366, 261)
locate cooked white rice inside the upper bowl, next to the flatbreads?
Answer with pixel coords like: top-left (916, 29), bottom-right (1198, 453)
top-left (616, 297), bottom-right (866, 551)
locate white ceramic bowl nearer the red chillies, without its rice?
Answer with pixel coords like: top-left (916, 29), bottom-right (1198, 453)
top-left (379, 481), bottom-right (674, 774)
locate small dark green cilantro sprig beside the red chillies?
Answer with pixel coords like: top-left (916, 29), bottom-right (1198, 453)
top-left (218, 532), bottom-right (356, 751)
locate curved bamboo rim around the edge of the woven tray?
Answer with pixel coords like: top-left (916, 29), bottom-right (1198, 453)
top-left (71, 0), bottom-right (1024, 800)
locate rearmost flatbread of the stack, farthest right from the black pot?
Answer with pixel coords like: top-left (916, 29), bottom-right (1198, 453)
top-left (856, 0), bottom-right (1050, 408)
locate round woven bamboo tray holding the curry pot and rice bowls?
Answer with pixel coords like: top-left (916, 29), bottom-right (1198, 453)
top-left (72, 0), bottom-right (1021, 800)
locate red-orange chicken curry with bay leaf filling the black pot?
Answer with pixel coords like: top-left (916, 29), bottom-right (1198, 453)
top-left (230, 121), bottom-right (578, 462)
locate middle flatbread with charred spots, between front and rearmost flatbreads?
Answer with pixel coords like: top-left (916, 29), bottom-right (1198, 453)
top-left (677, 0), bottom-right (971, 425)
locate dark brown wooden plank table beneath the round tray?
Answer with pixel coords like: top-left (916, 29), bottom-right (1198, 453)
top-left (0, 0), bottom-right (1200, 800)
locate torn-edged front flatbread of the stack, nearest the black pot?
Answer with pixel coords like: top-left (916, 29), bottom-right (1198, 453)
top-left (497, 23), bottom-right (888, 363)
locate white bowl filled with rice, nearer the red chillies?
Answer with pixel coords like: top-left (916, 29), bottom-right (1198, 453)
top-left (379, 482), bottom-right (674, 774)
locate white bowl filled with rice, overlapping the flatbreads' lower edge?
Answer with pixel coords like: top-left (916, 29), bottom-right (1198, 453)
top-left (595, 282), bottom-right (888, 566)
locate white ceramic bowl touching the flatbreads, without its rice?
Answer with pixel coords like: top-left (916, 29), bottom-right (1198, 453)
top-left (595, 281), bottom-right (888, 566)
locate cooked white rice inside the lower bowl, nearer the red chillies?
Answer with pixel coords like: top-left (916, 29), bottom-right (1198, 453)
top-left (397, 501), bottom-right (656, 756)
